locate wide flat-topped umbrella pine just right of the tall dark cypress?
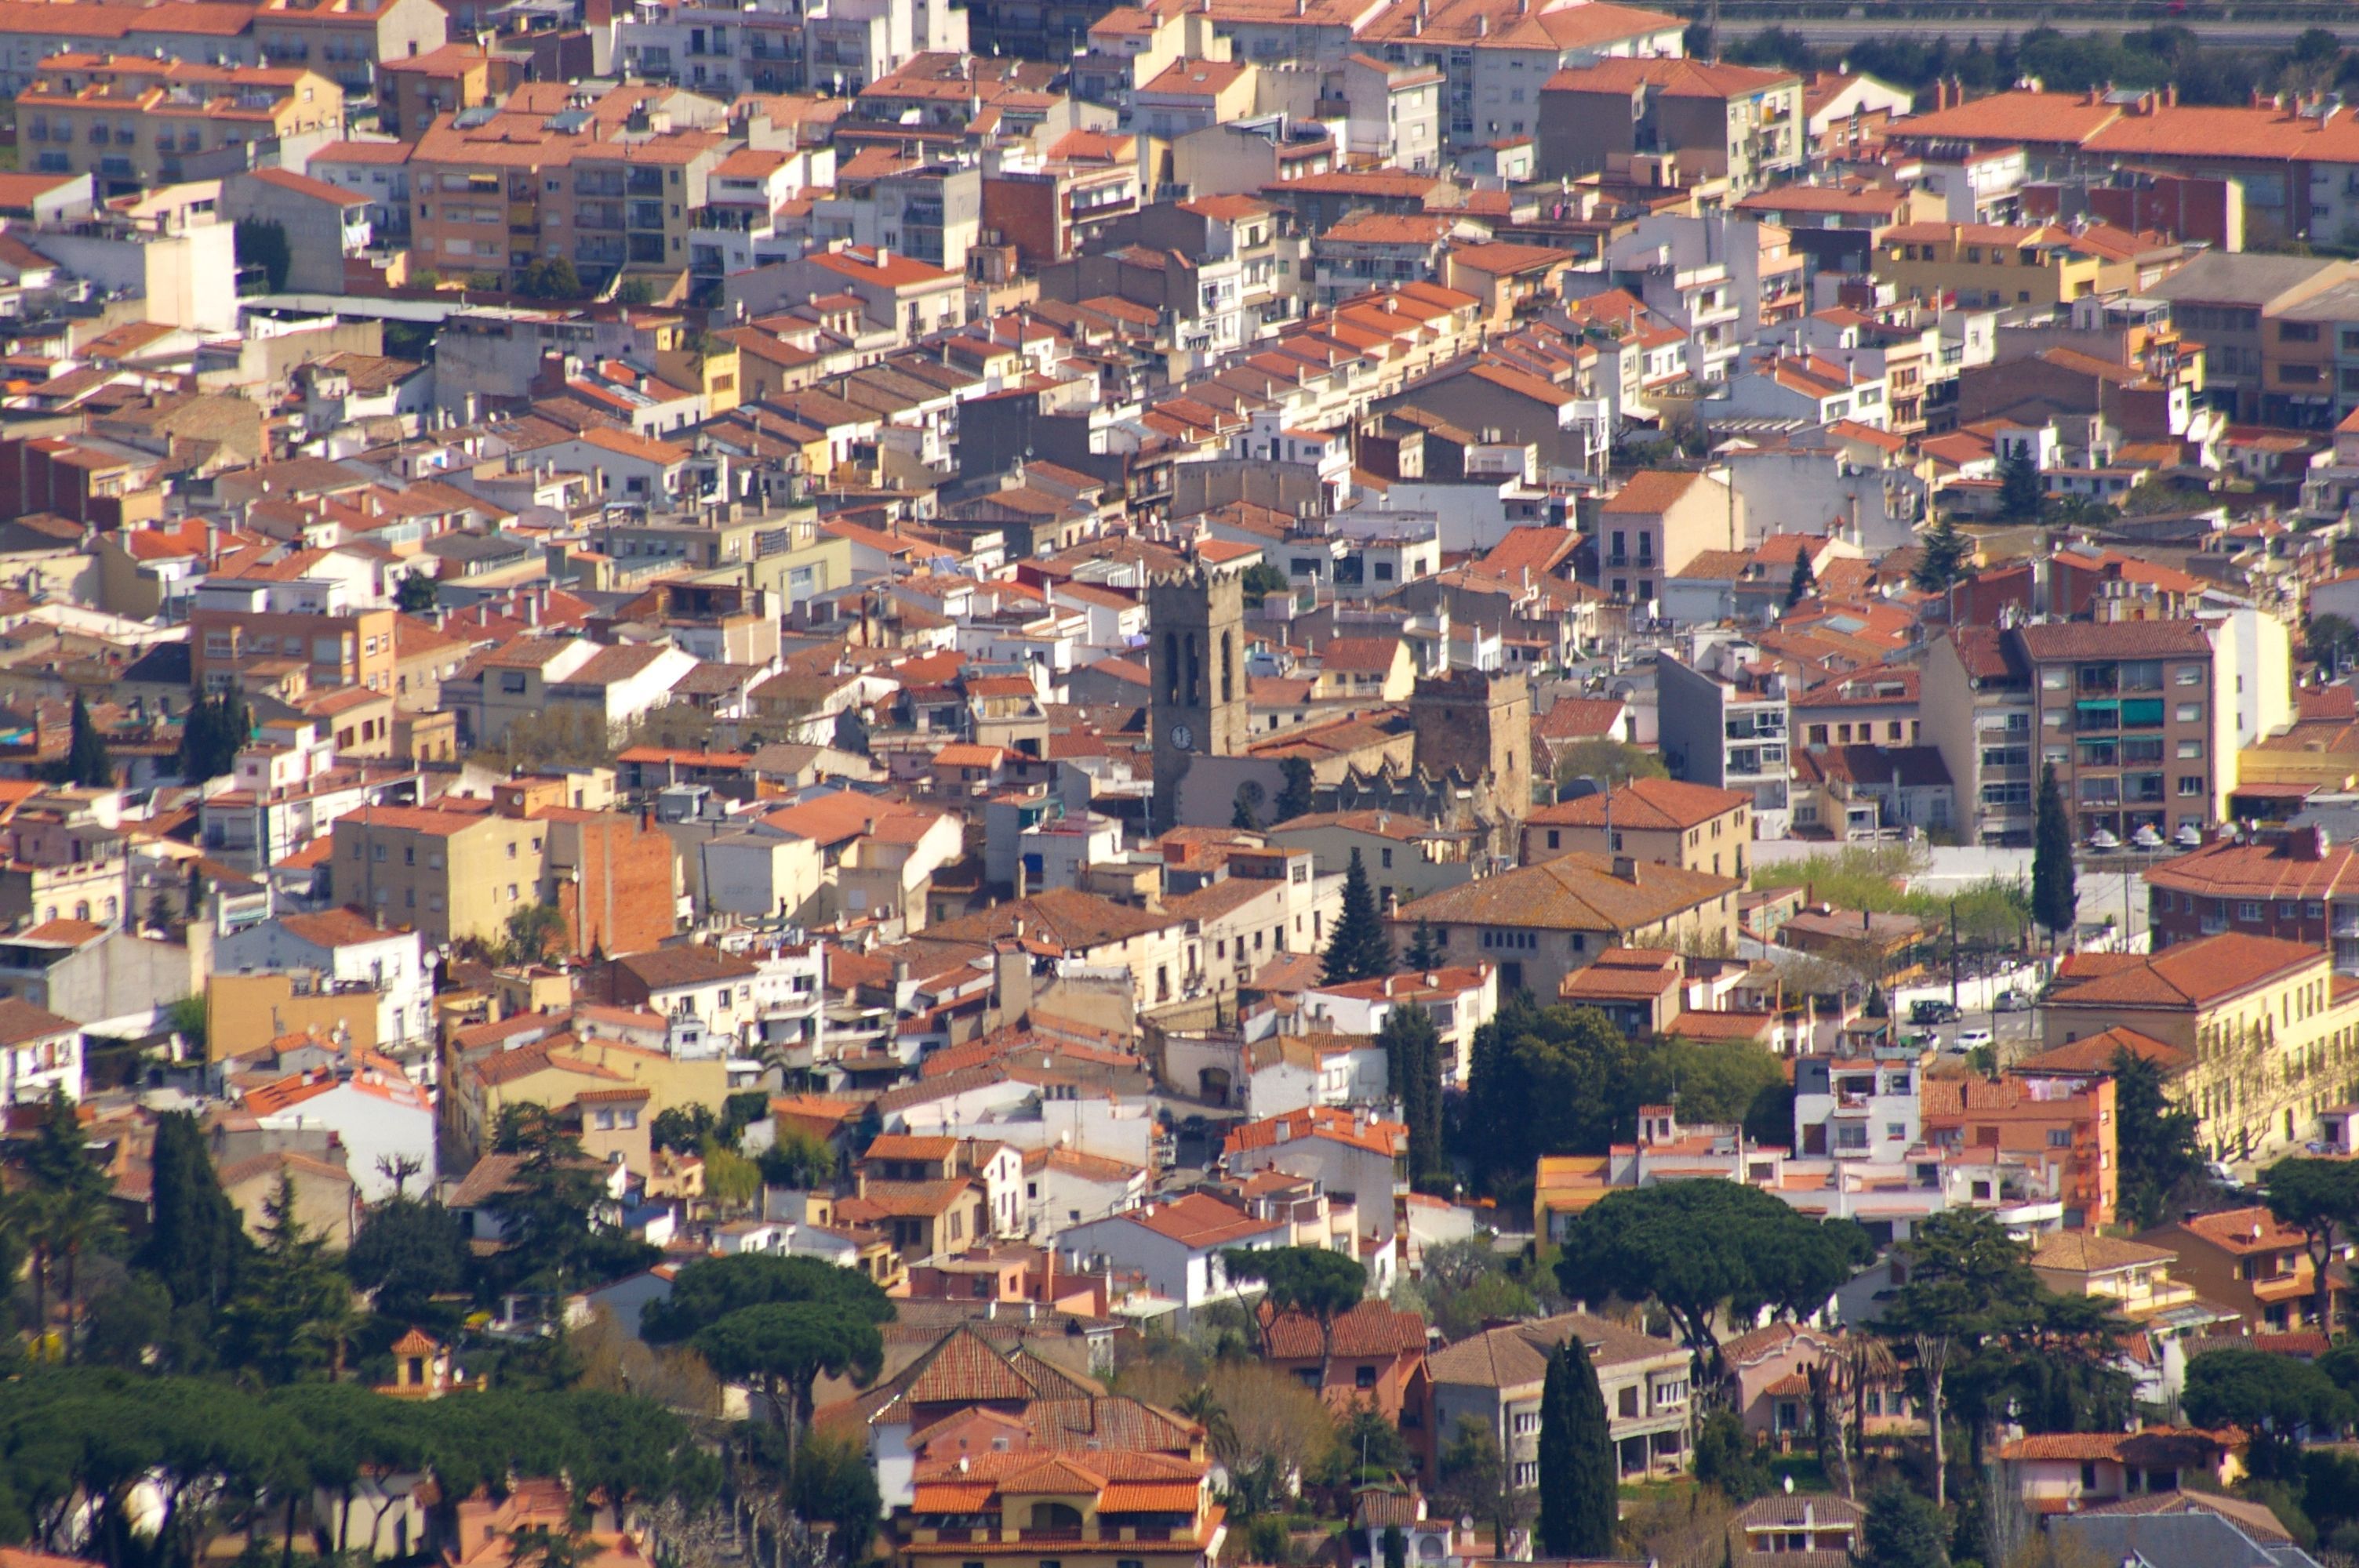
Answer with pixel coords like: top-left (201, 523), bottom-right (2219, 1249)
top-left (1557, 1179), bottom-right (1873, 1377)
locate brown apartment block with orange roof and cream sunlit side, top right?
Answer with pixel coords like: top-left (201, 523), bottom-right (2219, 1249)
top-left (1517, 59), bottom-right (1807, 198)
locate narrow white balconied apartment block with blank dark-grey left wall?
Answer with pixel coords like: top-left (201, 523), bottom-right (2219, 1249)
top-left (1656, 639), bottom-right (1793, 840)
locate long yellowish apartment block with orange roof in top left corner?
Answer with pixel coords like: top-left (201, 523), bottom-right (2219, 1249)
top-left (16, 53), bottom-right (344, 196)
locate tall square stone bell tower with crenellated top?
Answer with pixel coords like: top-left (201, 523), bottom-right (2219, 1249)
top-left (1147, 568), bottom-right (1248, 833)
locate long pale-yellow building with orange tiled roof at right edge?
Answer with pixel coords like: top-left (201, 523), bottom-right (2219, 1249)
top-left (2015, 931), bottom-right (2359, 1160)
